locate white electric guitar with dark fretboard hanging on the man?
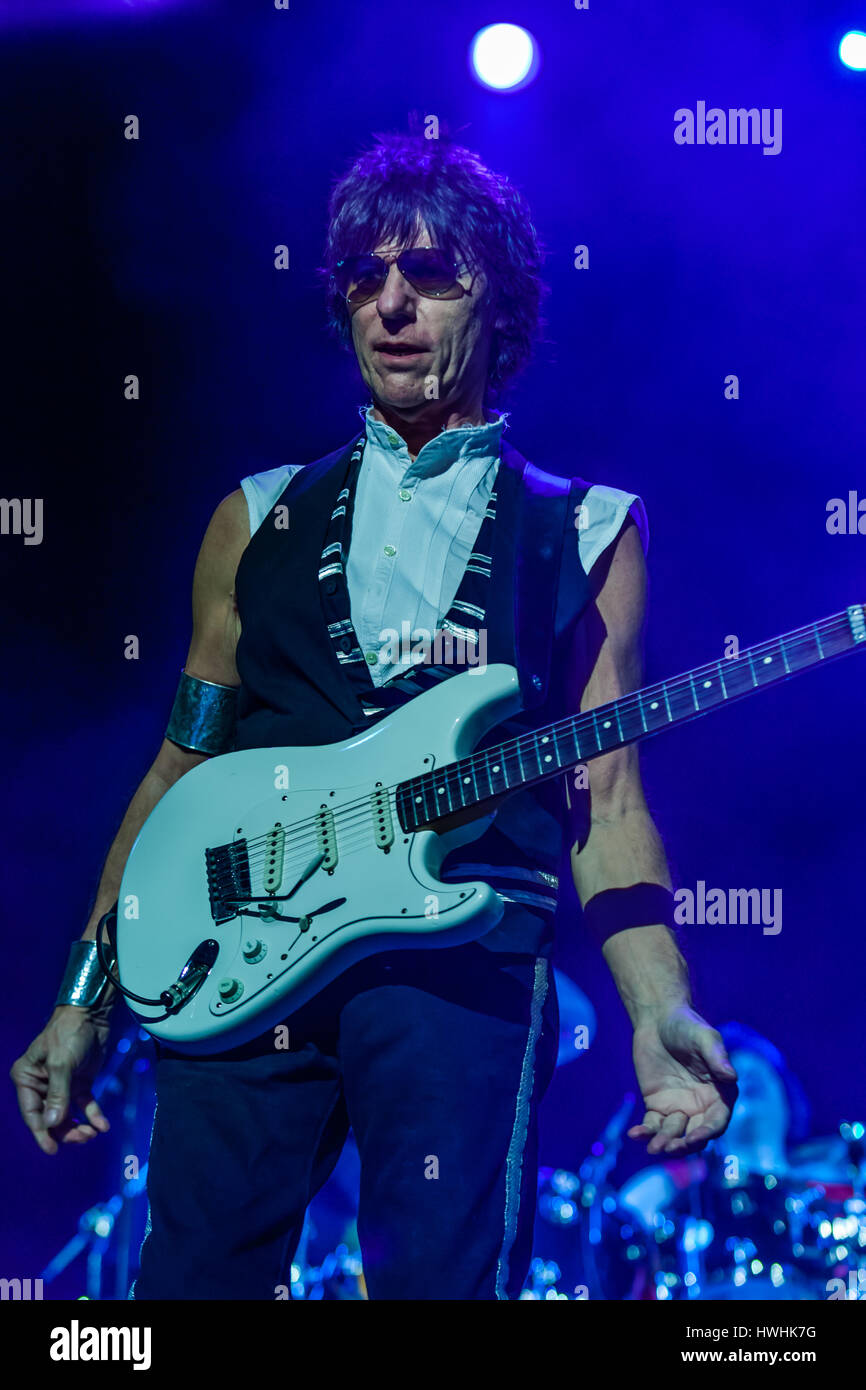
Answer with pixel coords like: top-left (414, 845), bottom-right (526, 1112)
top-left (111, 605), bottom-right (866, 1052)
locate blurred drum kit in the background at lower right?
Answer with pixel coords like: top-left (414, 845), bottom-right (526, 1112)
top-left (521, 1125), bottom-right (866, 1301)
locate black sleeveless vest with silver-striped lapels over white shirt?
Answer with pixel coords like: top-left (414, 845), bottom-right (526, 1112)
top-left (235, 432), bottom-right (600, 954)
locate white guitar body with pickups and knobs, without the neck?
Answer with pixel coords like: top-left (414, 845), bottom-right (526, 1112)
top-left (117, 664), bottom-right (521, 1054)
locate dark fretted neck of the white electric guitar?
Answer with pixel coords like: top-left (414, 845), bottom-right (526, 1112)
top-left (396, 603), bottom-right (866, 830)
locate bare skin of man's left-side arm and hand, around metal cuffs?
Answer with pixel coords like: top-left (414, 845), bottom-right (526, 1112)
top-left (10, 489), bottom-right (249, 1154)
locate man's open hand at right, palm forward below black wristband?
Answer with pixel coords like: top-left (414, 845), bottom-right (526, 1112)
top-left (628, 1005), bottom-right (737, 1156)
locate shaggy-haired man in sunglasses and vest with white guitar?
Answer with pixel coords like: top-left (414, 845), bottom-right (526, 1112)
top-left (11, 135), bottom-right (735, 1300)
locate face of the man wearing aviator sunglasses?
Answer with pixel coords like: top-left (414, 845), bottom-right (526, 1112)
top-left (349, 227), bottom-right (491, 420)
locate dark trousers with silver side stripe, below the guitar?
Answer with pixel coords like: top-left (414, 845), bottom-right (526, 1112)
top-left (129, 922), bottom-right (559, 1300)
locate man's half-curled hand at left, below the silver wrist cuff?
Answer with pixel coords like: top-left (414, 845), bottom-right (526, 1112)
top-left (10, 1004), bottom-right (110, 1154)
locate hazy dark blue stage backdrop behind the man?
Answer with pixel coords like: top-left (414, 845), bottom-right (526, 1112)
top-left (0, 0), bottom-right (866, 1293)
